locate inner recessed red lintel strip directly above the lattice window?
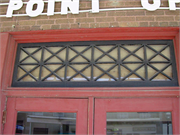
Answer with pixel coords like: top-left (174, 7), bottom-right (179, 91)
top-left (8, 32), bottom-right (176, 43)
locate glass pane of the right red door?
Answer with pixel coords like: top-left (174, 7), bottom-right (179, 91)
top-left (107, 112), bottom-right (172, 135)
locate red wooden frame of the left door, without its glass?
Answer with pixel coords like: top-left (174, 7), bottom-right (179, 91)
top-left (4, 98), bottom-right (88, 135)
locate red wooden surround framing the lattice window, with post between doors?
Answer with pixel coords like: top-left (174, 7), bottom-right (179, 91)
top-left (0, 27), bottom-right (180, 134)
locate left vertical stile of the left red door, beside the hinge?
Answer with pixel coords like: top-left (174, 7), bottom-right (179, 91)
top-left (3, 98), bottom-right (17, 134)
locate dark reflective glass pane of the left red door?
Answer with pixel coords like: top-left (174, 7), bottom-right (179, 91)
top-left (16, 112), bottom-right (76, 135)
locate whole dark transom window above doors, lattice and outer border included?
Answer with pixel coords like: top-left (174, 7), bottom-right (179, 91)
top-left (12, 40), bottom-right (178, 87)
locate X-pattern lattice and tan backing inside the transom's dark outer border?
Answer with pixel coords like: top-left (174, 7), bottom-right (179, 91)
top-left (17, 44), bottom-right (173, 82)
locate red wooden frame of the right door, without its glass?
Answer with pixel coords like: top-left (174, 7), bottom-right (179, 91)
top-left (94, 98), bottom-right (180, 135)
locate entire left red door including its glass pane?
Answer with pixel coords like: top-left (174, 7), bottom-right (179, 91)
top-left (4, 98), bottom-right (88, 134)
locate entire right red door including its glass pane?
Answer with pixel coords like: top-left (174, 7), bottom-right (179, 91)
top-left (94, 98), bottom-right (179, 135)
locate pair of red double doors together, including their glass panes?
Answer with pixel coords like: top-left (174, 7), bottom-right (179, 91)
top-left (4, 98), bottom-right (179, 135)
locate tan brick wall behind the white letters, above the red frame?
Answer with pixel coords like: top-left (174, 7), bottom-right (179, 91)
top-left (0, 0), bottom-right (180, 32)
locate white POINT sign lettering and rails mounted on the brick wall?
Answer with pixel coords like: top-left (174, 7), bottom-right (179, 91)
top-left (0, 0), bottom-right (180, 17)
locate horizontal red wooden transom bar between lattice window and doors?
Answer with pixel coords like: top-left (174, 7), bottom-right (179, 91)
top-left (4, 87), bottom-right (180, 97)
